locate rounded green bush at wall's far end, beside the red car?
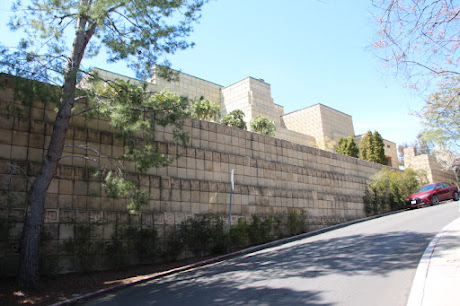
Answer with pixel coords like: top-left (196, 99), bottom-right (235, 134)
top-left (363, 168), bottom-right (424, 215)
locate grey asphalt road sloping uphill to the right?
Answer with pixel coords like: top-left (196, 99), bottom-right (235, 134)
top-left (84, 202), bottom-right (460, 306)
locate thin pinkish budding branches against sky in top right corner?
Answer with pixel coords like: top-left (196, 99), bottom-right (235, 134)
top-left (373, 0), bottom-right (460, 84)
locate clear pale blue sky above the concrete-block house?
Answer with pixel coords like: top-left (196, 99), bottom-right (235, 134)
top-left (0, 0), bottom-right (424, 144)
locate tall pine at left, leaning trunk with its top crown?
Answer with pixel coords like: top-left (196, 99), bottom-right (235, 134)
top-left (0, 0), bottom-right (205, 287)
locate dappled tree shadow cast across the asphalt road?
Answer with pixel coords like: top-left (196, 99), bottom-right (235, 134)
top-left (87, 232), bottom-right (434, 305)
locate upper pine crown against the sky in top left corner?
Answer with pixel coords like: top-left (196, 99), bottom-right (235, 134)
top-left (2, 0), bottom-right (206, 85)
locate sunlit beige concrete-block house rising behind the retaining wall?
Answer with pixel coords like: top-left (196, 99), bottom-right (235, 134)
top-left (87, 68), bottom-right (398, 168)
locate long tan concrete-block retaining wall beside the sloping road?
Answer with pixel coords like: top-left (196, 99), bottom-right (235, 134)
top-left (0, 75), bottom-right (382, 271)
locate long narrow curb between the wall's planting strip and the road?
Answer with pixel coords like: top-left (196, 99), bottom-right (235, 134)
top-left (51, 210), bottom-right (405, 306)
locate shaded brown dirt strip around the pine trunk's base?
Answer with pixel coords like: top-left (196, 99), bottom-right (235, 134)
top-left (0, 258), bottom-right (211, 306)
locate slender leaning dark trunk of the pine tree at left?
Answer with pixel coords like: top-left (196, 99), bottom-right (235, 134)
top-left (17, 19), bottom-right (96, 288)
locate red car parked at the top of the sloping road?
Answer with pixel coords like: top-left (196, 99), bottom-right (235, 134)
top-left (406, 182), bottom-right (459, 208)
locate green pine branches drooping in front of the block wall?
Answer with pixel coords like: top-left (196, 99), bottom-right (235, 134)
top-left (87, 80), bottom-right (189, 212)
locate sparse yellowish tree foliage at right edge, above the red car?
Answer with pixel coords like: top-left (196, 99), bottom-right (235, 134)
top-left (418, 77), bottom-right (460, 152)
